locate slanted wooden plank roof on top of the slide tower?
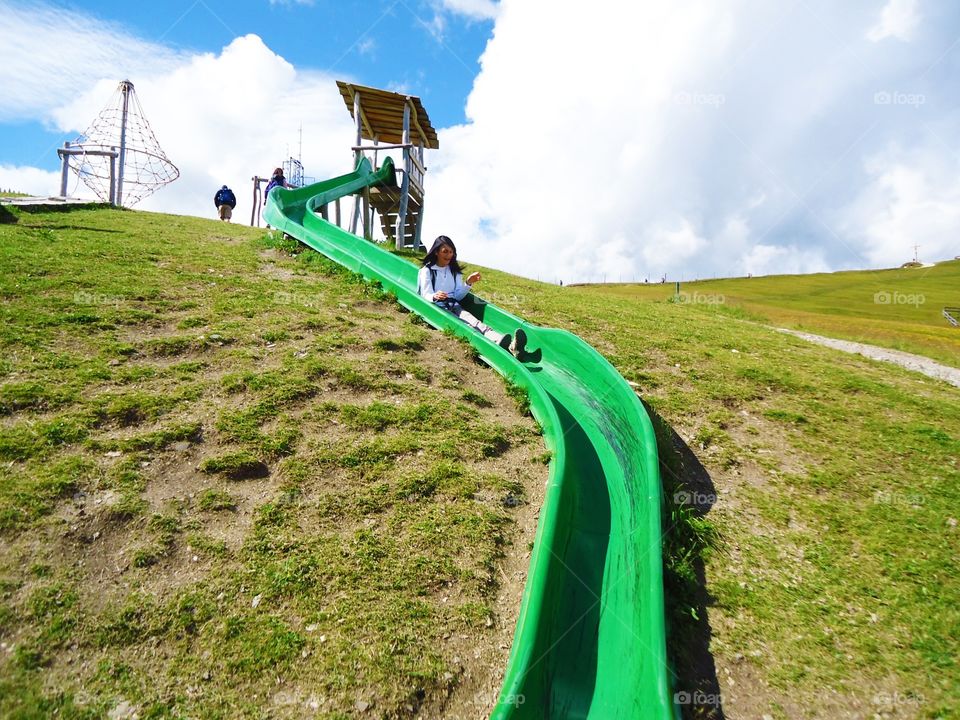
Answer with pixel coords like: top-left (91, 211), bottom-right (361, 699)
top-left (337, 80), bottom-right (440, 150)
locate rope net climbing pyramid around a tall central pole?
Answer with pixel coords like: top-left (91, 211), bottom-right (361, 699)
top-left (71, 80), bottom-right (180, 207)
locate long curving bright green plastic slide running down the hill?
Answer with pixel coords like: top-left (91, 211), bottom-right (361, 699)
top-left (264, 159), bottom-right (677, 720)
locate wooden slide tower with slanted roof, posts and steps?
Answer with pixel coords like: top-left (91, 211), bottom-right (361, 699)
top-left (337, 80), bottom-right (440, 249)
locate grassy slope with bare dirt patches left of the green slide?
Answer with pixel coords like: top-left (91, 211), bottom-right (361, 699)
top-left (0, 208), bottom-right (547, 718)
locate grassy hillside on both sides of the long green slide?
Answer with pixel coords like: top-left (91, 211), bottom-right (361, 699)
top-left (0, 202), bottom-right (960, 720)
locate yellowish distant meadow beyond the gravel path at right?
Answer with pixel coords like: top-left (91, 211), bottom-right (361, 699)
top-left (576, 260), bottom-right (960, 367)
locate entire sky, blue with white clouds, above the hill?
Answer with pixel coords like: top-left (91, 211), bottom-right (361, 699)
top-left (0, 0), bottom-right (960, 282)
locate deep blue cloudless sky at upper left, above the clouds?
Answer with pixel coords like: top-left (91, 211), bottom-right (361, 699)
top-left (0, 0), bottom-right (493, 169)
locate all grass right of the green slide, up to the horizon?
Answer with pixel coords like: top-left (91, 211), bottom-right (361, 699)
top-left (461, 262), bottom-right (960, 720)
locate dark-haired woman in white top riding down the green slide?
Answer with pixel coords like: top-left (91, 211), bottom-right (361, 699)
top-left (417, 235), bottom-right (527, 355)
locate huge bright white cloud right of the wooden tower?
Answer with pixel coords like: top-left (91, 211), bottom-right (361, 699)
top-left (424, 0), bottom-right (960, 282)
